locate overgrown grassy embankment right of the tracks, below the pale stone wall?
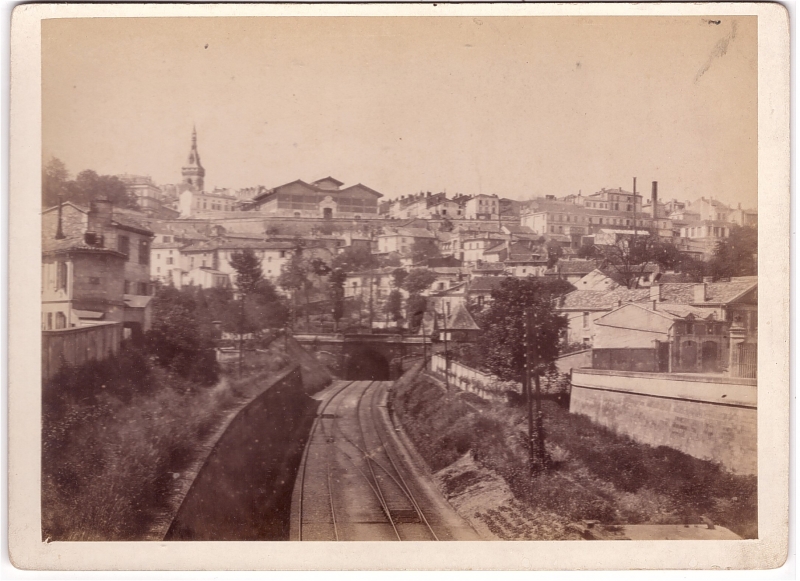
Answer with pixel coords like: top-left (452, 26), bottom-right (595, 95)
top-left (394, 375), bottom-right (757, 538)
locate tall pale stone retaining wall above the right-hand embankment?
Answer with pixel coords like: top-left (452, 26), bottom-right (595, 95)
top-left (570, 369), bottom-right (758, 474)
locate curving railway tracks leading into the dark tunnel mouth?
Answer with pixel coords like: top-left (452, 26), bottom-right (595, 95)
top-left (292, 381), bottom-right (449, 541)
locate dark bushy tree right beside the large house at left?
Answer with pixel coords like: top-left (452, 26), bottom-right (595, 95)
top-left (145, 286), bottom-right (219, 385)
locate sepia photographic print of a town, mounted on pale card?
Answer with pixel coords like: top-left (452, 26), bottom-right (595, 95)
top-left (11, 0), bottom-right (789, 568)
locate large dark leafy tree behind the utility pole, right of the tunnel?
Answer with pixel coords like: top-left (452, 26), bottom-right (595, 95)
top-left (476, 277), bottom-right (567, 381)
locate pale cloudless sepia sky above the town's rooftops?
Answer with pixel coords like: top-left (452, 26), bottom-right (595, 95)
top-left (42, 17), bottom-right (757, 207)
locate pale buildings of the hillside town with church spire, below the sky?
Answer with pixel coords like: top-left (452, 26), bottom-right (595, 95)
top-left (43, 131), bottom-right (758, 344)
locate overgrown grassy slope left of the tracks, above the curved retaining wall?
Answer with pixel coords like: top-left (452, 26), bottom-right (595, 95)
top-left (42, 340), bottom-right (289, 541)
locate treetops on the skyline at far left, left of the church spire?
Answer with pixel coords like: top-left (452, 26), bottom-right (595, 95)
top-left (42, 157), bottom-right (138, 208)
